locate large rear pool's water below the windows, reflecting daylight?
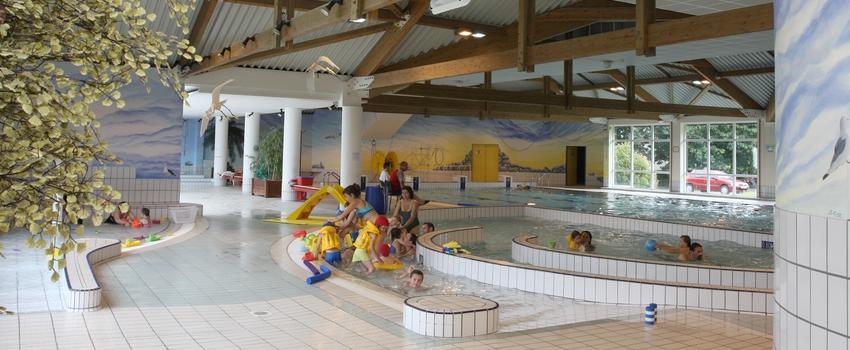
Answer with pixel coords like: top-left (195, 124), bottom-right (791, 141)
top-left (420, 188), bottom-right (773, 232)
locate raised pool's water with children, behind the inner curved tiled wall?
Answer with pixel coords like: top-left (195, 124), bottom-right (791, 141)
top-left (434, 217), bottom-right (773, 269)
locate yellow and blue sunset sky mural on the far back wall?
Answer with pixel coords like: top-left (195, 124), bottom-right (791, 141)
top-left (302, 110), bottom-right (607, 183)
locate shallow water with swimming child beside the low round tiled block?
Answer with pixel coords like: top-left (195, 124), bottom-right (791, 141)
top-left (336, 261), bottom-right (643, 332)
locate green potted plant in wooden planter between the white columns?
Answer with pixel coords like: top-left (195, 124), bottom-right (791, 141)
top-left (251, 129), bottom-right (283, 198)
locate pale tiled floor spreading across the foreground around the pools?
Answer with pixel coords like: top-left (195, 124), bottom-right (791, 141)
top-left (0, 188), bottom-right (771, 349)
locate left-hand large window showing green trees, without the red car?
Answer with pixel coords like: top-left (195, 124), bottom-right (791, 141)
top-left (614, 125), bottom-right (670, 191)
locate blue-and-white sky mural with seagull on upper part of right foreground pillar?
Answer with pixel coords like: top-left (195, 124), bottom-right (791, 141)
top-left (775, 0), bottom-right (850, 219)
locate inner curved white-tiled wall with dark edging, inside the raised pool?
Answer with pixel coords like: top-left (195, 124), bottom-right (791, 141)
top-left (511, 235), bottom-right (773, 289)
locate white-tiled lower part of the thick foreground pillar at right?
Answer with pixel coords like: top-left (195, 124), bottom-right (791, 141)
top-left (773, 207), bottom-right (850, 349)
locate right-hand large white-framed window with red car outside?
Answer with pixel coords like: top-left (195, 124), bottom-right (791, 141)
top-left (684, 123), bottom-right (758, 197)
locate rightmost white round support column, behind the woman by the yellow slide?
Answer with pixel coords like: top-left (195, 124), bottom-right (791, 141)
top-left (339, 102), bottom-right (363, 187)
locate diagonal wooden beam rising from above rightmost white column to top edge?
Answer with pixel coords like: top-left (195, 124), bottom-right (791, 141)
top-left (354, 0), bottom-right (430, 75)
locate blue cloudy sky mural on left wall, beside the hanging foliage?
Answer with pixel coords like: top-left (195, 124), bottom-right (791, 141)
top-left (92, 81), bottom-right (183, 179)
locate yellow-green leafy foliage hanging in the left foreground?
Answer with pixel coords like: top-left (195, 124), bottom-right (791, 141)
top-left (0, 0), bottom-right (201, 281)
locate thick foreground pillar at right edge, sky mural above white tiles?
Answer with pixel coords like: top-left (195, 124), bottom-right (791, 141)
top-left (773, 0), bottom-right (850, 350)
